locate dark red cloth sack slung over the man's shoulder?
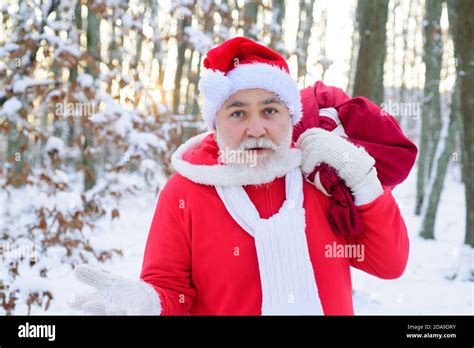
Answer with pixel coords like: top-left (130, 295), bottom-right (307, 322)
top-left (293, 81), bottom-right (418, 237)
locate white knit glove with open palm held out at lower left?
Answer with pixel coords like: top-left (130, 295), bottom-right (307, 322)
top-left (70, 264), bottom-right (161, 315)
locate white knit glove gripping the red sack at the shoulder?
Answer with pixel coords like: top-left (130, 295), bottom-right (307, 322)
top-left (297, 128), bottom-right (383, 205)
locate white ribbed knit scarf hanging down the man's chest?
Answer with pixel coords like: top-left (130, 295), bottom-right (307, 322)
top-left (215, 167), bottom-right (323, 315)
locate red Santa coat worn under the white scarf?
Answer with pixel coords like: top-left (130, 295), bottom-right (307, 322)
top-left (140, 134), bottom-right (409, 315)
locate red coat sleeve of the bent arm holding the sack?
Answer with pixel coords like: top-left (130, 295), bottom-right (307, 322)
top-left (348, 188), bottom-right (409, 279)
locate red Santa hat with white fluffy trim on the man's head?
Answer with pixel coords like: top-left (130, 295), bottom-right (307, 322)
top-left (199, 37), bottom-right (302, 129)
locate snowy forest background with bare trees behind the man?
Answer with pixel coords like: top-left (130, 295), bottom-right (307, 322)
top-left (0, 0), bottom-right (474, 315)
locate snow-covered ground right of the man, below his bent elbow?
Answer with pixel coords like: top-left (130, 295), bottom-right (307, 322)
top-left (352, 167), bottom-right (474, 315)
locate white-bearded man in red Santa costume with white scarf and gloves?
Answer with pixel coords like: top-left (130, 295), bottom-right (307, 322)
top-left (73, 37), bottom-right (409, 315)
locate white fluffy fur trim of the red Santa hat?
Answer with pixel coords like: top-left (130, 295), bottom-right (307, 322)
top-left (199, 63), bottom-right (303, 129)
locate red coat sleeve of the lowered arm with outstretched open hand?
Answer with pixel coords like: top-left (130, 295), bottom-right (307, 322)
top-left (140, 187), bottom-right (197, 315)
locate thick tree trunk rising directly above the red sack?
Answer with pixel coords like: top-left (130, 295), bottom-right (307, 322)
top-left (353, 0), bottom-right (388, 105)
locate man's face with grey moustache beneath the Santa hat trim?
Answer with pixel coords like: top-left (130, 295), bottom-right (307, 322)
top-left (216, 88), bottom-right (292, 167)
